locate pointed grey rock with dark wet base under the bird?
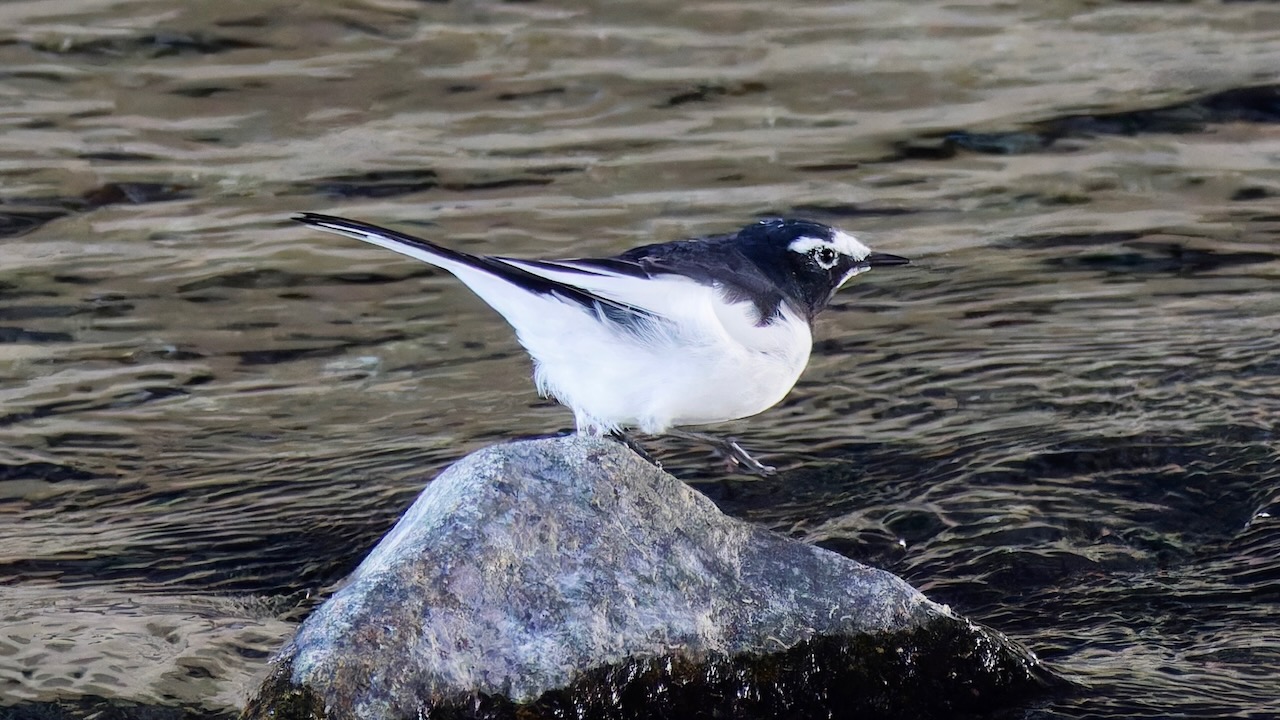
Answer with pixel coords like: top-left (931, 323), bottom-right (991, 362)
top-left (244, 436), bottom-right (1053, 719)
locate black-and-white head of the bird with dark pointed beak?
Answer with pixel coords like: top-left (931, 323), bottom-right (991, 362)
top-left (739, 219), bottom-right (910, 319)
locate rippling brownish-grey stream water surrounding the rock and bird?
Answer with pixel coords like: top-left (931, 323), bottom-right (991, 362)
top-left (0, 0), bottom-right (1280, 717)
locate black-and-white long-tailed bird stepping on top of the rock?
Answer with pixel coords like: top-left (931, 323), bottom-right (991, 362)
top-left (293, 213), bottom-right (910, 475)
